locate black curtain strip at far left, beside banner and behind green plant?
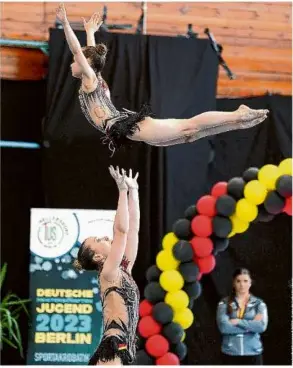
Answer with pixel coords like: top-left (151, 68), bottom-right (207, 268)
top-left (1, 80), bottom-right (46, 365)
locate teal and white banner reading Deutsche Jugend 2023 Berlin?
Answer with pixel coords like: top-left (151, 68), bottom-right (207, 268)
top-left (27, 208), bottom-right (115, 365)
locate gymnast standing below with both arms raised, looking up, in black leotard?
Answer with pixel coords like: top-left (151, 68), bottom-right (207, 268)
top-left (74, 166), bottom-right (140, 365)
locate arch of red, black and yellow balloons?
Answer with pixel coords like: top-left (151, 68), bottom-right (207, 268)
top-left (136, 158), bottom-right (292, 365)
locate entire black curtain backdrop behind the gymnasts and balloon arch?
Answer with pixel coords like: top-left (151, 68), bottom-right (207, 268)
top-left (1, 31), bottom-right (292, 365)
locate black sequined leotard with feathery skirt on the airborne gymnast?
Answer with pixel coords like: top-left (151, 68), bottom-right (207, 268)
top-left (79, 75), bottom-right (151, 153)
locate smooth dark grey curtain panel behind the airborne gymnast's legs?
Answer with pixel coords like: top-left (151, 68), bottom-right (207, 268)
top-left (149, 37), bottom-right (218, 229)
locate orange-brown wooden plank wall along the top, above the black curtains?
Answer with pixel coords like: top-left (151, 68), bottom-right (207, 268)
top-left (1, 2), bottom-right (292, 97)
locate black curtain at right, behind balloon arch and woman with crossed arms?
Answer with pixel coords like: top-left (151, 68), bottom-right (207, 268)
top-left (180, 96), bottom-right (292, 365)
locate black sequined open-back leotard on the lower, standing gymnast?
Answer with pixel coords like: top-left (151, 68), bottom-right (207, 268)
top-left (89, 259), bottom-right (139, 365)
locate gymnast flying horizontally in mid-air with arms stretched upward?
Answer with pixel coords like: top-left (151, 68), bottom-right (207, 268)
top-left (57, 4), bottom-right (269, 152)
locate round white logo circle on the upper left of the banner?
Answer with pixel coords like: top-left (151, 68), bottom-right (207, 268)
top-left (31, 214), bottom-right (78, 258)
